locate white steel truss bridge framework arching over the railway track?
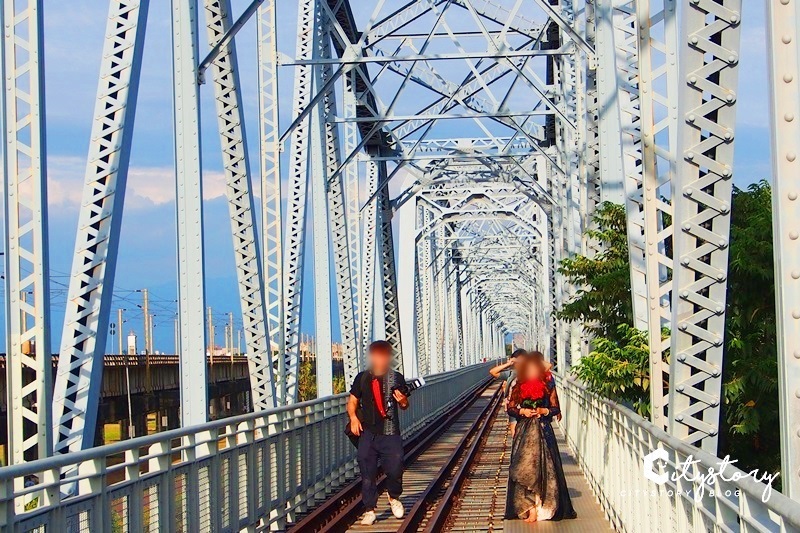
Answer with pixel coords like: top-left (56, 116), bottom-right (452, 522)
top-left (0, 0), bottom-right (800, 531)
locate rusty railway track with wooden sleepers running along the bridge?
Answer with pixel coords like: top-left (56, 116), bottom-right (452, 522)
top-left (289, 385), bottom-right (502, 533)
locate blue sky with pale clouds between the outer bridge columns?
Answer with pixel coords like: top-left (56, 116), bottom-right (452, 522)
top-left (32, 0), bottom-right (771, 351)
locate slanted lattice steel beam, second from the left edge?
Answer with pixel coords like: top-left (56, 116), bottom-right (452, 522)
top-left (53, 0), bottom-right (149, 453)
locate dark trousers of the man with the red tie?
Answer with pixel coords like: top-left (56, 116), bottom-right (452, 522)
top-left (358, 429), bottom-right (403, 511)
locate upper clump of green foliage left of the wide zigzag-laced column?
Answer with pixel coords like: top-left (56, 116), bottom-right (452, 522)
top-left (556, 202), bottom-right (633, 341)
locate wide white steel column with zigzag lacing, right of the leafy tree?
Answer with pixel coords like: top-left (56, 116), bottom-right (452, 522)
top-left (669, 0), bottom-right (742, 453)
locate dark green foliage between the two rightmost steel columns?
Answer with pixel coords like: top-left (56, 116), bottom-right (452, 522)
top-left (720, 181), bottom-right (780, 472)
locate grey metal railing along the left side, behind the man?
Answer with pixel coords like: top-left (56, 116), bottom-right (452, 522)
top-left (0, 364), bottom-right (488, 533)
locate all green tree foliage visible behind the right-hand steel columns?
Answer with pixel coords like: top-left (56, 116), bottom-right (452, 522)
top-left (557, 186), bottom-right (780, 478)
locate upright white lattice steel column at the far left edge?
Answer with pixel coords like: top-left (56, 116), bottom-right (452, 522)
top-left (0, 0), bottom-right (53, 468)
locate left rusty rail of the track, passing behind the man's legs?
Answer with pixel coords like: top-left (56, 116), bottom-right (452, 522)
top-left (287, 379), bottom-right (494, 533)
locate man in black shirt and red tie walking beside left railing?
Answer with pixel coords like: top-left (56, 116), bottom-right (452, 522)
top-left (347, 341), bottom-right (408, 526)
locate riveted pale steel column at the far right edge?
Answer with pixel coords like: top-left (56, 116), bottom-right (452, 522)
top-left (767, 0), bottom-right (800, 500)
